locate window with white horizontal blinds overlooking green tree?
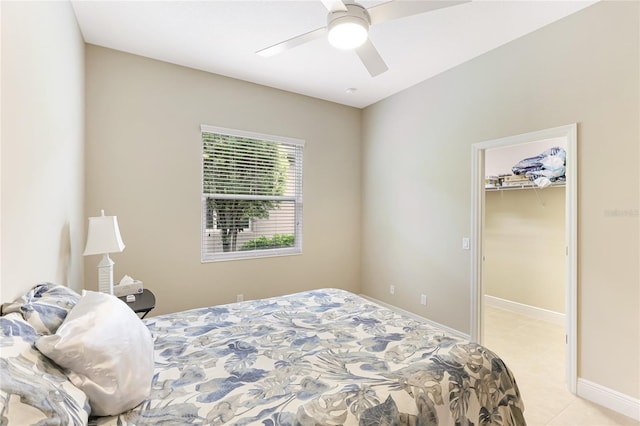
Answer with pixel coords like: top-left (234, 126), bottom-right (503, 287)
top-left (201, 125), bottom-right (304, 262)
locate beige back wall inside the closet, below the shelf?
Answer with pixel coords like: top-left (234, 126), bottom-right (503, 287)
top-left (482, 187), bottom-right (566, 313)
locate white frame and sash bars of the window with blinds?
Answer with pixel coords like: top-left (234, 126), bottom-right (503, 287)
top-left (200, 124), bottom-right (305, 263)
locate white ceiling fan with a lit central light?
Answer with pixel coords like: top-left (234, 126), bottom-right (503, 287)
top-left (256, 0), bottom-right (471, 77)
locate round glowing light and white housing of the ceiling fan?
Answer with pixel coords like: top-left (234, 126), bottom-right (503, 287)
top-left (327, 4), bottom-right (371, 49)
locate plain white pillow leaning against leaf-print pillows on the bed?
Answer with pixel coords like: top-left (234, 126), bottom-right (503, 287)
top-left (36, 291), bottom-right (153, 416)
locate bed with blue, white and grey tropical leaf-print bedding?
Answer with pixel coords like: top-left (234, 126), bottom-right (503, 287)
top-left (0, 286), bottom-right (526, 426)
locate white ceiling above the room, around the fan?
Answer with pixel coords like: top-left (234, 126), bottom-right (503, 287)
top-left (71, 0), bottom-right (595, 108)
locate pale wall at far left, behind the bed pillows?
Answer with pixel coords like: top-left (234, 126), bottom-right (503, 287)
top-left (0, 2), bottom-right (86, 301)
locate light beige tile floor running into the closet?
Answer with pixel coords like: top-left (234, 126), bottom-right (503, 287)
top-left (484, 306), bottom-right (640, 426)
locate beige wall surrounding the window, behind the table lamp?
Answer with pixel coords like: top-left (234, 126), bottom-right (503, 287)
top-left (85, 45), bottom-right (361, 314)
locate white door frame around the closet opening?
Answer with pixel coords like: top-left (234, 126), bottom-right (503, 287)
top-left (471, 123), bottom-right (578, 394)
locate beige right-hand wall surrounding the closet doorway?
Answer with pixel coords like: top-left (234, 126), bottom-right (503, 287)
top-left (362, 2), bottom-right (640, 398)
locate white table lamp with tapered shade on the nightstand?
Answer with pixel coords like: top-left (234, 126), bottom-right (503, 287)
top-left (83, 210), bottom-right (124, 294)
